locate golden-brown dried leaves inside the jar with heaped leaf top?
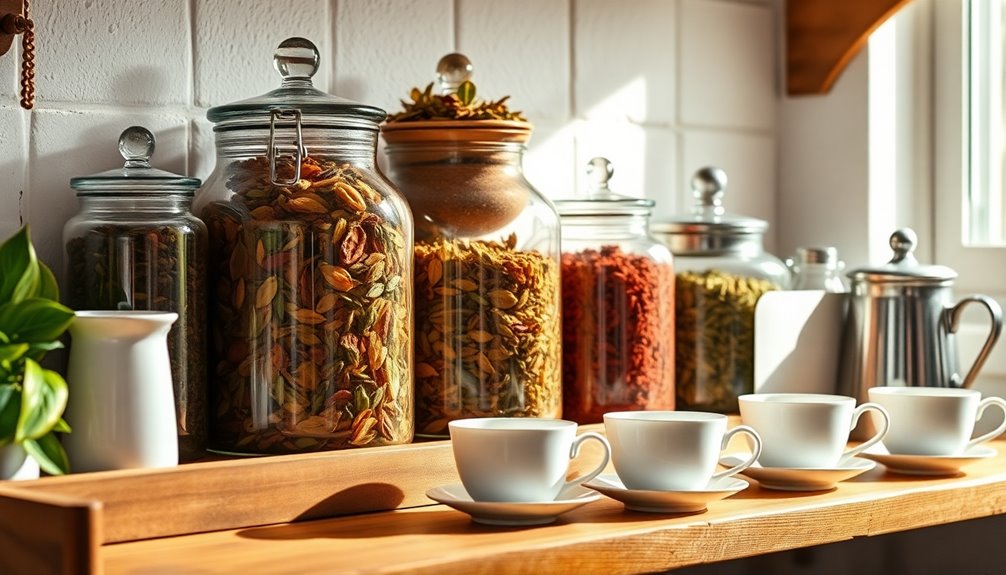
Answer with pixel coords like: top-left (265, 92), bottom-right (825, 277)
top-left (415, 234), bottom-right (561, 436)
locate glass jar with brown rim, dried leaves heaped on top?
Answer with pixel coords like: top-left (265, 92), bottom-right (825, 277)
top-left (381, 58), bottom-right (561, 437)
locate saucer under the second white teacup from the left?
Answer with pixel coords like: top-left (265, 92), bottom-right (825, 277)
top-left (583, 473), bottom-right (749, 513)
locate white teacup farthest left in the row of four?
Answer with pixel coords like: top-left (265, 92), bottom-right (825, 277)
top-left (449, 417), bottom-right (612, 503)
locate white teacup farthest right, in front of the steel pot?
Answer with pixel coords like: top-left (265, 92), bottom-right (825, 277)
top-left (867, 387), bottom-right (1006, 455)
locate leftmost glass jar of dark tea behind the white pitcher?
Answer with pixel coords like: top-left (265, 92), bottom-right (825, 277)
top-left (63, 126), bottom-right (207, 460)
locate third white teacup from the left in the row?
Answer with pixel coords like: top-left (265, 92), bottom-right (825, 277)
top-left (738, 393), bottom-right (888, 468)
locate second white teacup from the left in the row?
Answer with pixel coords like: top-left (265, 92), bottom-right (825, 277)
top-left (605, 411), bottom-right (762, 491)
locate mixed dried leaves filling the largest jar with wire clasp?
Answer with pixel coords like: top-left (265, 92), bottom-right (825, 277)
top-left (204, 158), bottom-right (412, 453)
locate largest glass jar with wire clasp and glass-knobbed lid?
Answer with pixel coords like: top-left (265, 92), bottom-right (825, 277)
top-left (196, 38), bottom-right (413, 453)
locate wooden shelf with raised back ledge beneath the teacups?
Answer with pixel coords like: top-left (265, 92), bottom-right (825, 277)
top-left (0, 426), bottom-right (1006, 575)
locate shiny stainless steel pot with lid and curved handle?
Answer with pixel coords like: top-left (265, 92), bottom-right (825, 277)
top-left (838, 228), bottom-right (1002, 402)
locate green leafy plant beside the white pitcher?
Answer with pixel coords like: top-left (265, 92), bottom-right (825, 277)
top-left (0, 226), bottom-right (73, 478)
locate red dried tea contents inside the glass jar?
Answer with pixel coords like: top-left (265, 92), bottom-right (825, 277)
top-left (562, 246), bottom-right (674, 423)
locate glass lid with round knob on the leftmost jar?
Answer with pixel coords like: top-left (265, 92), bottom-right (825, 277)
top-left (69, 126), bottom-right (202, 196)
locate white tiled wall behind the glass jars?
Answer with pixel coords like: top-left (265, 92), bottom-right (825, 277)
top-left (0, 0), bottom-right (781, 266)
